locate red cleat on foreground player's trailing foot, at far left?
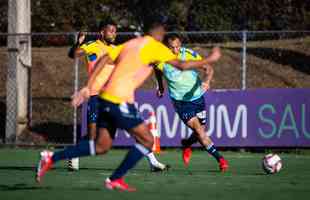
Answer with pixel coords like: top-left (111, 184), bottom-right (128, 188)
top-left (35, 150), bottom-right (53, 183)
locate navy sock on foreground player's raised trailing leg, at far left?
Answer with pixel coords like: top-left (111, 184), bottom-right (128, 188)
top-left (52, 140), bottom-right (96, 162)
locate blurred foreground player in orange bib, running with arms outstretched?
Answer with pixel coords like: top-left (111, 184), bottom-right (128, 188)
top-left (37, 19), bottom-right (221, 191)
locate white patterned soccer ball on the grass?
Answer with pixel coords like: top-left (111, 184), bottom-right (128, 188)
top-left (263, 153), bottom-right (282, 174)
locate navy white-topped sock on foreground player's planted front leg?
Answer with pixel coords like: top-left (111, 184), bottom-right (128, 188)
top-left (110, 144), bottom-right (150, 180)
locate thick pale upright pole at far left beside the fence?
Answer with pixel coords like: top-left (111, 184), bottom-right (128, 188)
top-left (5, 0), bottom-right (31, 143)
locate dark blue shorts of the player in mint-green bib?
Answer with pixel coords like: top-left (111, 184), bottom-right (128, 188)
top-left (172, 96), bottom-right (207, 125)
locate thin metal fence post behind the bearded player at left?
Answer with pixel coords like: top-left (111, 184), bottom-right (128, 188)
top-left (73, 33), bottom-right (79, 144)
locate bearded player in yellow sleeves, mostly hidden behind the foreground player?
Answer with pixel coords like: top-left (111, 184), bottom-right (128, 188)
top-left (68, 18), bottom-right (170, 172)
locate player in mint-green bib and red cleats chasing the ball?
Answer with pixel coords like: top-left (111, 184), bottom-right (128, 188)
top-left (155, 34), bottom-right (228, 171)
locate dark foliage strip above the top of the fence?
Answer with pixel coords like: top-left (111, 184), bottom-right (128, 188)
top-left (0, 0), bottom-right (310, 32)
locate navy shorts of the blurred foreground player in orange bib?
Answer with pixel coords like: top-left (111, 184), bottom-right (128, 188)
top-left (97, 98), bottom-right (143, 134)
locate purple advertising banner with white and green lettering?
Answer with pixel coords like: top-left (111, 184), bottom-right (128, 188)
top-left (82, 89), bottom-right (310, 147)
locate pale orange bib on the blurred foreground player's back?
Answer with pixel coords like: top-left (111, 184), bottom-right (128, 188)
top-left (101, 36), bottom-right (154, 103)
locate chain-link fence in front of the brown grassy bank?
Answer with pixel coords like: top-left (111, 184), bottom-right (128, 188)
top-left (0, 31), bottom-right (310, 145)
